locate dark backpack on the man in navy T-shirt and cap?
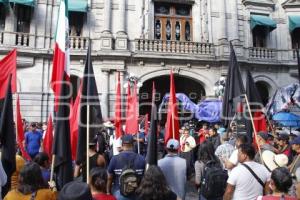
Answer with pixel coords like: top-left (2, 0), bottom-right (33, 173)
top-left (120, 154), bottom-right (139, 197)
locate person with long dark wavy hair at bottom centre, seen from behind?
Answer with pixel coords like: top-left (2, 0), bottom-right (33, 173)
top-left (136, 165), bottom-right (177, 200)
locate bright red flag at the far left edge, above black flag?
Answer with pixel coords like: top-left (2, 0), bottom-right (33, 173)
top-left (0, 49), bottom-right (17, 99)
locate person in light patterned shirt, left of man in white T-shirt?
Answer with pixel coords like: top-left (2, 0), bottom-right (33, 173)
top-left (215, 132), bottom-right (234, 169)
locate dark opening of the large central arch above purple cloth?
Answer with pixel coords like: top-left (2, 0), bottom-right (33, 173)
top-left (139, 74), bottom-right (206, 120)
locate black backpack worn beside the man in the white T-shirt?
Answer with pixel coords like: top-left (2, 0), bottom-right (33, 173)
top-left (200, 161), bottom-right (228, 199)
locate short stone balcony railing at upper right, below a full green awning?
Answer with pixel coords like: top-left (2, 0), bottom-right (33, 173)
top-left (249, 47), bottom-right (277, 60)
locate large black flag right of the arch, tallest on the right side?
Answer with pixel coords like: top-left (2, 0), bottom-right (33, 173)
top-left (222, 43), bottom-right (245, 127)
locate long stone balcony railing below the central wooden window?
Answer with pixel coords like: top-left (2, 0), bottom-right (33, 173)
top-left (135, 39), bottom-right (213, 55)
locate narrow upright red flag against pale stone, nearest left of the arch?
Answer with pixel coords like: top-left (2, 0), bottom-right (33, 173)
top-left (115, 73), bottom-right (122, 139)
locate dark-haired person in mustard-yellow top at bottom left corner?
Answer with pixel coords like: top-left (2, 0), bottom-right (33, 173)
top-left (4, 162), bottom-right (56, 200)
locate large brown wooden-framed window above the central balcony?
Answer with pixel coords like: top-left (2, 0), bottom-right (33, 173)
top-left (154, 3), bottom-right (192, 41)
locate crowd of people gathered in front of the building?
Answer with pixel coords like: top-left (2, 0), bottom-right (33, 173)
top-left (0, 119), bottom-right (300, 200)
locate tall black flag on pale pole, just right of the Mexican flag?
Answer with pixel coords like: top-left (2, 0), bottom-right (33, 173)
top-left (76, 44), bottom-right (102, 168)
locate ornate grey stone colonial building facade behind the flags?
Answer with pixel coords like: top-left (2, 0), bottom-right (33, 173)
top-left (0, 0), bottom-right (300, 121)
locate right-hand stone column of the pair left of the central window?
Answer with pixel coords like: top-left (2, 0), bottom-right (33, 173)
top-left (116, 0), bottom-right (128, 50)
